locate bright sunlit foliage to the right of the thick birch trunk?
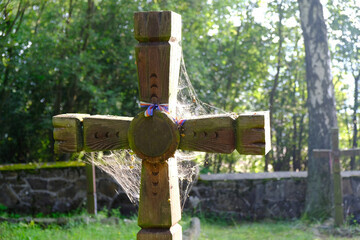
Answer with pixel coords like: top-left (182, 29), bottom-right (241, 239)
top-left (327, 0), bottom-right (360, 170)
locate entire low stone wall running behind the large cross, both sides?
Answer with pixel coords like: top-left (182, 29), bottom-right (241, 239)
top-left (0, 167), bottom-right (360, 219)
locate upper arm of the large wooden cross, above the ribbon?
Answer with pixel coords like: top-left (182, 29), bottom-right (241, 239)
top-left (134, 11), bottom-right (181, 112)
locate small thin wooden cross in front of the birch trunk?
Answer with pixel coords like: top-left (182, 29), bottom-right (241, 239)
top-left (313, 128), bottom-right (360, 226)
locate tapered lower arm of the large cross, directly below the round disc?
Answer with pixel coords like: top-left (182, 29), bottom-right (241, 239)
top-left (138, 158), bottom-right (181, 229)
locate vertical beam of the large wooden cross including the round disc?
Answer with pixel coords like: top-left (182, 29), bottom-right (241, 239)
top-left (134, 11), bottom-right (182, 240)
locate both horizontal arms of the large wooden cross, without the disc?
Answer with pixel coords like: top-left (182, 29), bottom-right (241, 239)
top-left (53, 112), bottom-right (270, 155)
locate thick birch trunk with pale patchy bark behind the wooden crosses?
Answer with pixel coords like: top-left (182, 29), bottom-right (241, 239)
top-left (298, 0), bottom-right (337, 219)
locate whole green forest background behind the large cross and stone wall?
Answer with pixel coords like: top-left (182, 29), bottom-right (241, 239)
top-left (0, 0), bottom-right (360, 173)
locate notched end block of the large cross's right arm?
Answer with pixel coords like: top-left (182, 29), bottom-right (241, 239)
top-left (235, 111), bottom-right (271, 155)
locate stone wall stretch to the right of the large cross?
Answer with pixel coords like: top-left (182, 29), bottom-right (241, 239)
top-left (186, 171), bottom-right (360, 220)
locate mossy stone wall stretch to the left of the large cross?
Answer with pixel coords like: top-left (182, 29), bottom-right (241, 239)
top-left (0, 167), bottom-right (136, 214)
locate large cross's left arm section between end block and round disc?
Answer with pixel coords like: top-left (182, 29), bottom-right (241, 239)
top-left (83, 115), bottom-right (133, 152)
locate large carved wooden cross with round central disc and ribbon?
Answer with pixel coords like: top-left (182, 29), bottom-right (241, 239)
top-left (53, 11), bottom-right (270, 240)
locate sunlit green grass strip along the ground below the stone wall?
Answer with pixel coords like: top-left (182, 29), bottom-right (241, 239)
top-left (0, 214), bottom-right (360, 240)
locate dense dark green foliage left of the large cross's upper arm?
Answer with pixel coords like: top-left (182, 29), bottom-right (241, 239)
top-left (0, 1), bottom-right (138, 163)
